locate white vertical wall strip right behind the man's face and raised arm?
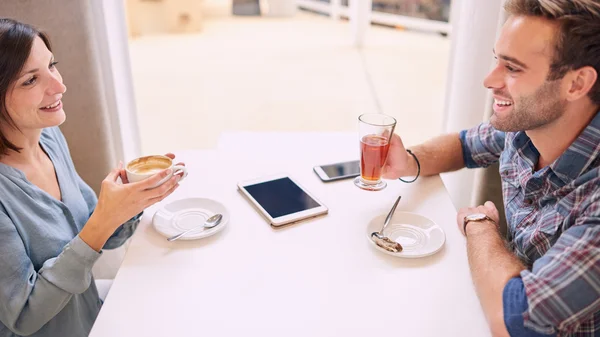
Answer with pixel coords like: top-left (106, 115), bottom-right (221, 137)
top-left (442, 0), bottom-right (504, 208)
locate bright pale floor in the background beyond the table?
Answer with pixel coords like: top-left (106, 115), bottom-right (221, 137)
top-left (130, 12), bottom-right (450, 154)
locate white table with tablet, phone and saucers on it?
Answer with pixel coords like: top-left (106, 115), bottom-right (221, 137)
top-left (91, 133), bottom-right (490, 337)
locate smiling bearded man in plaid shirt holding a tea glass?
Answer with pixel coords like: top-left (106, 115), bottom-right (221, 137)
top-left (385, 0), bottom-right (600, 336)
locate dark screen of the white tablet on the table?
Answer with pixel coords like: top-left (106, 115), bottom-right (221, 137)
top-left (244, 177), bottom-right (321, 218)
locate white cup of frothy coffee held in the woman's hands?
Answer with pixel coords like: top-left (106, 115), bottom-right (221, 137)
top-left (125, 155), bottom-right (188, 188)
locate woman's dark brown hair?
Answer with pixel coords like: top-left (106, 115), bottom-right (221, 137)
top-left (0, 18), bottom-right (52, 157)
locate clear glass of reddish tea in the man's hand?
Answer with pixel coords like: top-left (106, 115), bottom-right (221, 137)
top-left (354, 114), bottom-right (396, 191)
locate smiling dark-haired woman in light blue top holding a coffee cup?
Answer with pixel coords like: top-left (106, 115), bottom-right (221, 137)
top-left (0, 19), bottom-right (179, 337)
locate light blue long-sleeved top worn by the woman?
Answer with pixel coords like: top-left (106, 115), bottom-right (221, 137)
top-left (0, 127), bottom-right (140, 337)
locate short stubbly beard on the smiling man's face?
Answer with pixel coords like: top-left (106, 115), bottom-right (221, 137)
top-left (490, 81), bottom-right (566, 132)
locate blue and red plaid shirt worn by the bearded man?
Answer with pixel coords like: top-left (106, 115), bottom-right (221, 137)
top-left (461, 113), bottom-right (600, 336)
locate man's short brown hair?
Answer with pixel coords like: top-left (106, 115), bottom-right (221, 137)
top-left (504, 0), bottom-right (600, 105)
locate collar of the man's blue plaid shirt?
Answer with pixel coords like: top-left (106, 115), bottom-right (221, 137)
top-left (511, 111), bottom-right (600, 188)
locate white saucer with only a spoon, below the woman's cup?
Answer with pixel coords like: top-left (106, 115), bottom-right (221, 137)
top-left (152, 198), bottom-right (229, 240)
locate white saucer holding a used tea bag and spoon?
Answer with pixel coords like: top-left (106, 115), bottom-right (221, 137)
top-left (366, 212), bottom-right (446, 258)
